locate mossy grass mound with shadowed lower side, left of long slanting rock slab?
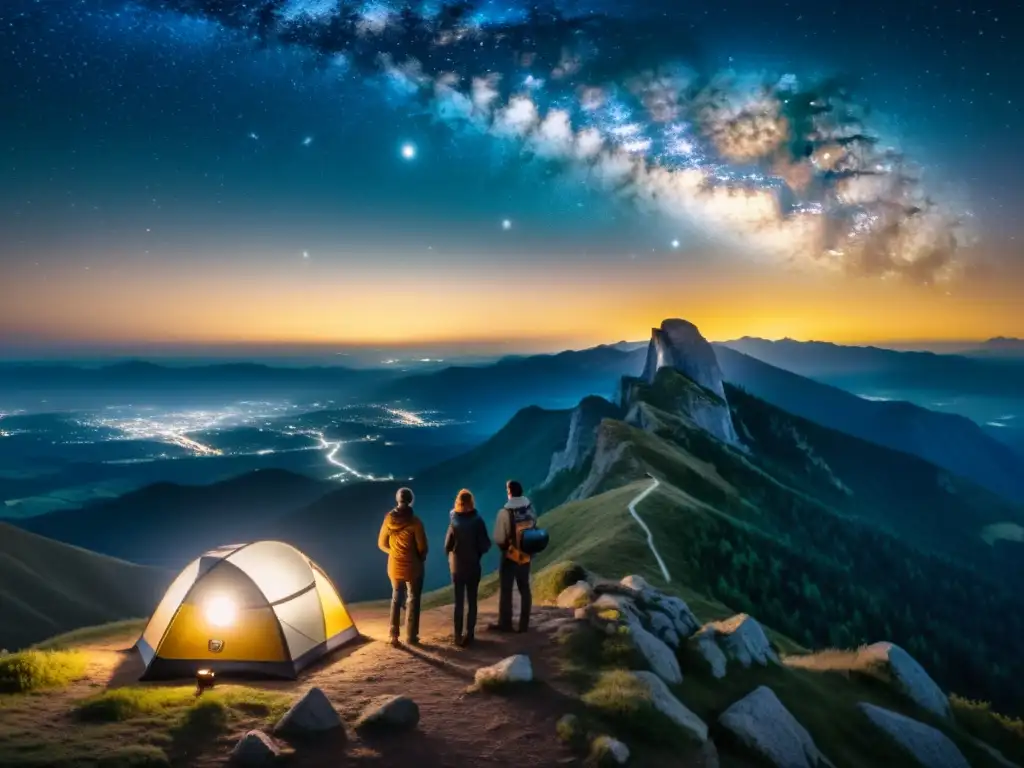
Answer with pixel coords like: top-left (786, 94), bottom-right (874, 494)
top-left (583, 670), bottom-right (693, 748)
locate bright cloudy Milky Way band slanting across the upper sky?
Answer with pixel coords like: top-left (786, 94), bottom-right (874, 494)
top-left (70, 0), bottom-right (969, 283)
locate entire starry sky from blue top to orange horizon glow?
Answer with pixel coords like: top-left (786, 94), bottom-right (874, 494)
top-left (0, 0), bottom-right (1024, 354)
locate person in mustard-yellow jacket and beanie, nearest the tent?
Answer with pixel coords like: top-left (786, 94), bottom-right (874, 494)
top-left (377, 488), bottom-right (427, 645)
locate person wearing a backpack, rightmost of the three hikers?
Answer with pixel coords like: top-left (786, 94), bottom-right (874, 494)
top-left (489, 480), bottom-right (537, 632)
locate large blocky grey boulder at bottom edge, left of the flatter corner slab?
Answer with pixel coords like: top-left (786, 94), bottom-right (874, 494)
top-left (718, 685), bottom-right (831, 768)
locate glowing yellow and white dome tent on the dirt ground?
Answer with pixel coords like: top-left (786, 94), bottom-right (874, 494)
top-left (135, 542), bottom-right (358, 680)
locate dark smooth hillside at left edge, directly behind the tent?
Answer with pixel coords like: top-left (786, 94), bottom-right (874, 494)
top-left (0, 522), bottom-right (173, 650)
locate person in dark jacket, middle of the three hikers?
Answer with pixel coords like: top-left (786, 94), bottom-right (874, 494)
top-left (444, 488), bottom-right (490, 647)
